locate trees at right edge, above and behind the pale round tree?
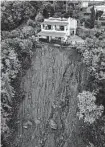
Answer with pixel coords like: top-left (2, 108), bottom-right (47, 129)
top-left (77, 31), bottom-right (105, 106)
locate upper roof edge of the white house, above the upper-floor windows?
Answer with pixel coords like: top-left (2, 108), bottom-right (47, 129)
top-left (42, 20), bottom-right (68, 26)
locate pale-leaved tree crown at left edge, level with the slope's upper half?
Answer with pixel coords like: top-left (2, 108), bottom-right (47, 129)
top-left (1, 41), bottom-right (20, 78)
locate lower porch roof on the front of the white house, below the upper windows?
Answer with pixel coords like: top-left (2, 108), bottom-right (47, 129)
top-left (38, 31), bottom-right (66, 37)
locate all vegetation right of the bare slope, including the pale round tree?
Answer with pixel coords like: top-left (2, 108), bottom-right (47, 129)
top-left (77, 30), bottom-right (105, 147)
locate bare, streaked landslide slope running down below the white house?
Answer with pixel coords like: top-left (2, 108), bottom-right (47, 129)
top-left (11, 45), bottom-right (88, 147)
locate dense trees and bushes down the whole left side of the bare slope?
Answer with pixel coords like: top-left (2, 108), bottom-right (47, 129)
top-left (1, 2), bottom-right (42, 145)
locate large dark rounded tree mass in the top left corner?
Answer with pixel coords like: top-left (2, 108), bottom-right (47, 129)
top-left (1, 1), bottom-right (38, 30)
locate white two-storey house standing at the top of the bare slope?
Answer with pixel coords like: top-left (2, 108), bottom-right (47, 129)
top-left (38, 17), bottom-right (77, 42)
